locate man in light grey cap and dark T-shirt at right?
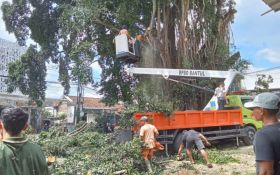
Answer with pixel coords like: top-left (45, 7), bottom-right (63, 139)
top-left (245, 92), bottom-right (280, 175)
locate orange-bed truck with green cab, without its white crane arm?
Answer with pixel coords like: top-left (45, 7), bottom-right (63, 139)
top-left (134, 95), bottom-right (262, 150)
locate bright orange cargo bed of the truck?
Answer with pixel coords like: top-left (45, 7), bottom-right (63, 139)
top-left (134, 109), bottom-right (243, 131)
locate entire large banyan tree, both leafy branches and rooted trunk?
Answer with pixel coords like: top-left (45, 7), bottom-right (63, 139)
top-left (2, 0), bottom-right (247, 108)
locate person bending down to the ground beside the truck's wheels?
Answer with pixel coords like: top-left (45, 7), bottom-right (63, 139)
top-left (177, 129), bottom-right (213, 168)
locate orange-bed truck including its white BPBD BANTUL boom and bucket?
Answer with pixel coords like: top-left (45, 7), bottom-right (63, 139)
top-left (115, 35), bottom-right (262, 150)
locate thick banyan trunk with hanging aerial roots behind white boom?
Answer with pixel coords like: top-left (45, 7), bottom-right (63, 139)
top-left (140, 0), bottom-right (235, 109)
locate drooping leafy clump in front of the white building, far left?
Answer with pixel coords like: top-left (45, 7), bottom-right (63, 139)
top-left (7, 45), bottom-right (47, 106)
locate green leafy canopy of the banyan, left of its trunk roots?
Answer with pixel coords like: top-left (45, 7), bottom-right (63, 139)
top-left (2, 0), bottom-right (151, 105)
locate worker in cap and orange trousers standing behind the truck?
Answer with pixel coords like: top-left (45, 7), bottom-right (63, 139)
top-left (140, 116), bottom-right (159, 173)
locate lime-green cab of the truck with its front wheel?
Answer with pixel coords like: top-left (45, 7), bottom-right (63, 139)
top-left (225, 95), bottom-right (263, 145)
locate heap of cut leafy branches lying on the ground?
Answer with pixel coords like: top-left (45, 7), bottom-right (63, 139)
top-left (29, 128), bottom-right (160, 175)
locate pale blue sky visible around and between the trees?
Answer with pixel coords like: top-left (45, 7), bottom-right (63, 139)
top-left (0, 0), bottom-right (280, 96)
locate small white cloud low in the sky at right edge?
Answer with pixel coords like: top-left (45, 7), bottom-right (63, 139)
top-left (257, 48), bottom-right (280, 63)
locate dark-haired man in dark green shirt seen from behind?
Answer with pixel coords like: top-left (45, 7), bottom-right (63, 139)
top-left (0, 108), bottom-right (50, 175)
